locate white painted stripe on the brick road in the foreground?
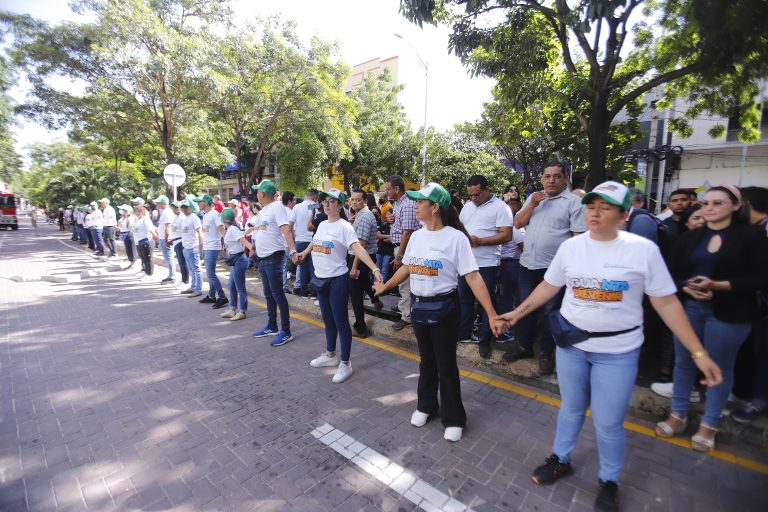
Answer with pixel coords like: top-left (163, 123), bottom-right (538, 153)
top-left (312, 423), bottom-right (474, 512)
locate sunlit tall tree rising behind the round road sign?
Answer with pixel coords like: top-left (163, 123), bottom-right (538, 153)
top-left (9, 0), bottom-right (228, 170)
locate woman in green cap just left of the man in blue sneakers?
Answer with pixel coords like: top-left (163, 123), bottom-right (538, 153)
top-left (219, 208), bottom-right (253, 320)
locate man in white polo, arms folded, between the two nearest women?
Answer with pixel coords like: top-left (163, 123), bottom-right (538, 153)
top-left (459, 174), bottom-right (512, 358)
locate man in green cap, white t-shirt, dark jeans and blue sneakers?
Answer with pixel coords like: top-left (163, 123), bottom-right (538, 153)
top-left (251, 180), bottom-right (298, 347)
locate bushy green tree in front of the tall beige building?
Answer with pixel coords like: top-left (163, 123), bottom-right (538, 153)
top-left (339, 70), bottom-right (418, 189)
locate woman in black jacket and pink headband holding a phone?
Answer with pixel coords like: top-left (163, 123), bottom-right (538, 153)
top-left (656, 184), bottom-right (768, 452)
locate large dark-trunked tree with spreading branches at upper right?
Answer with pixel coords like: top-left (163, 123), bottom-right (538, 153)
top-left (400, 0), bottom-right (768, 188)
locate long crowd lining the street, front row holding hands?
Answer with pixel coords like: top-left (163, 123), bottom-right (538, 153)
top-left (57, 167), bottom-right (768, 510)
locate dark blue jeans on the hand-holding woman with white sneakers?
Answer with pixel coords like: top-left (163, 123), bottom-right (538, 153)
top-left (317, 274), bottom-right (352, 363)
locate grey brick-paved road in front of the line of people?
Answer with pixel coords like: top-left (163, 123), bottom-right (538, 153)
top-left (0, 228), bottom-right (768, 512)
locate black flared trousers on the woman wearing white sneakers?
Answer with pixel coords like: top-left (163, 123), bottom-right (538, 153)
top-left (411, 299), bottom-right (467, 428)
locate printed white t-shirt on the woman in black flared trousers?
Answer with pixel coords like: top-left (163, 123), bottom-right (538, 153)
top-left (403, 226), bottom-right (478, 297)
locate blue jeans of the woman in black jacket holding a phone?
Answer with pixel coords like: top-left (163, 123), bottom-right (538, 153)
top-left (672, 300), bottom-right (752, 427)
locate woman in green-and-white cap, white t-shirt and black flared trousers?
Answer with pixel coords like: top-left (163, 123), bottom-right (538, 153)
top-left (373, 183), bottom-right (504, 442)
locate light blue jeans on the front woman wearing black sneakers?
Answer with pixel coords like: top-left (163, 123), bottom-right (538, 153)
top-left (552, 347), bottom-right (640, 482)
